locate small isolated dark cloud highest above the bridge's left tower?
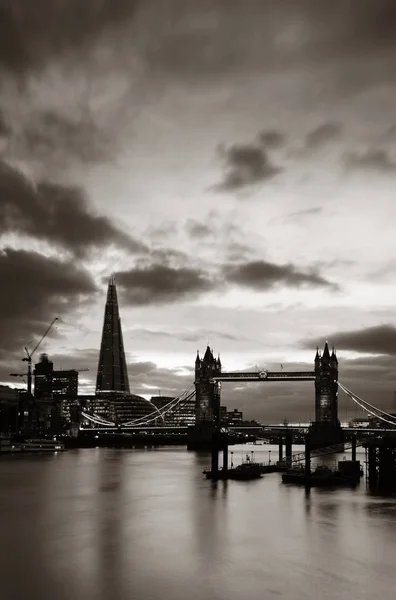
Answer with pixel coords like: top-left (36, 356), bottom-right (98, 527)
top-left (215, 144), bottom-right (282, 191)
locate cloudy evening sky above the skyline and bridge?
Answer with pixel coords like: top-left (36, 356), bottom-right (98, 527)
top-left (0, 0), bottom-right (396, 422)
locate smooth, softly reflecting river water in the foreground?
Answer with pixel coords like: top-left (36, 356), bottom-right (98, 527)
top-left (0, 446), bottom-right (396, 600)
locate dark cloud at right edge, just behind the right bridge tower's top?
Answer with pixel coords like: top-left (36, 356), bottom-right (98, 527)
top-left (303, 324), bottom-right (396, 356)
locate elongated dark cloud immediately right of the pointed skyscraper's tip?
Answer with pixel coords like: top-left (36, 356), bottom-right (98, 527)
top-left (116, 264), bottom-right (213, 305)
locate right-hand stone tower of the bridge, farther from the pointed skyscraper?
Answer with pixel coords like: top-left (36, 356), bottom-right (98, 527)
top-left (311, 341), bottom-right (343, 447)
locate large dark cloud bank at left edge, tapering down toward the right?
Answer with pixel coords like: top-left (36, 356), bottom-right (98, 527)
top-left (0, 163), bottom-right (145, 255)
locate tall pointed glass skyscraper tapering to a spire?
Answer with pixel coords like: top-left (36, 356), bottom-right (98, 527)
top-left (96, 276), bottom-right (130, 394)
